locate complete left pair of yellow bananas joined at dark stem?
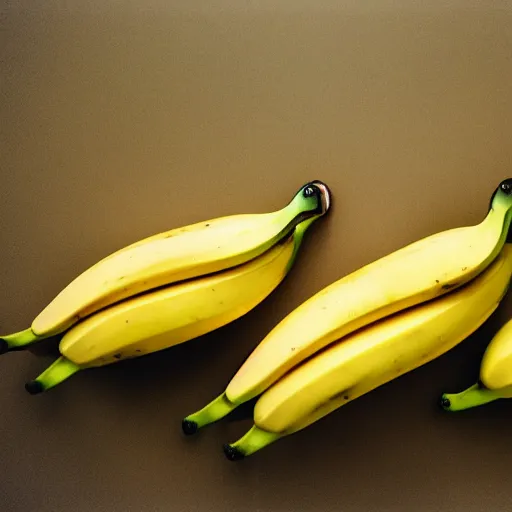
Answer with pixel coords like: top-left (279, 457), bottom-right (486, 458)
top-left (0, 181), bottom-right (331, 394)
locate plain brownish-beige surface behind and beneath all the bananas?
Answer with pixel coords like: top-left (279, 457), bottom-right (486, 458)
top-left (0, 0), bottom-right (512, 512)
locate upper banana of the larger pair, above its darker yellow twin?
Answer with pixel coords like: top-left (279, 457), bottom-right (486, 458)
top-left (182, 179), bottom-right (512, 434)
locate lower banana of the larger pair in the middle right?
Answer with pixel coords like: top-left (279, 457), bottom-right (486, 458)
top-left (224, 244), bottom-right (512, 460)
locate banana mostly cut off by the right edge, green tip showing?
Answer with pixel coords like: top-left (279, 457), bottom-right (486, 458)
top-left (440, 320), bottom-right (512, 412)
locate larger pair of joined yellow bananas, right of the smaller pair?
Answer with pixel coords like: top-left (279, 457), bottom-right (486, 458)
top-left (182, 179), bottom-right (512, 460)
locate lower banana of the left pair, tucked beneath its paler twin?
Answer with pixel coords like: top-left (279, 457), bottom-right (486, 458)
top-left (25, 216), bottom-right (319, 394)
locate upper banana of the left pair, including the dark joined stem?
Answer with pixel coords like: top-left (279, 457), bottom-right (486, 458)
top-left (0, 181), bottom-right (330, 353)
